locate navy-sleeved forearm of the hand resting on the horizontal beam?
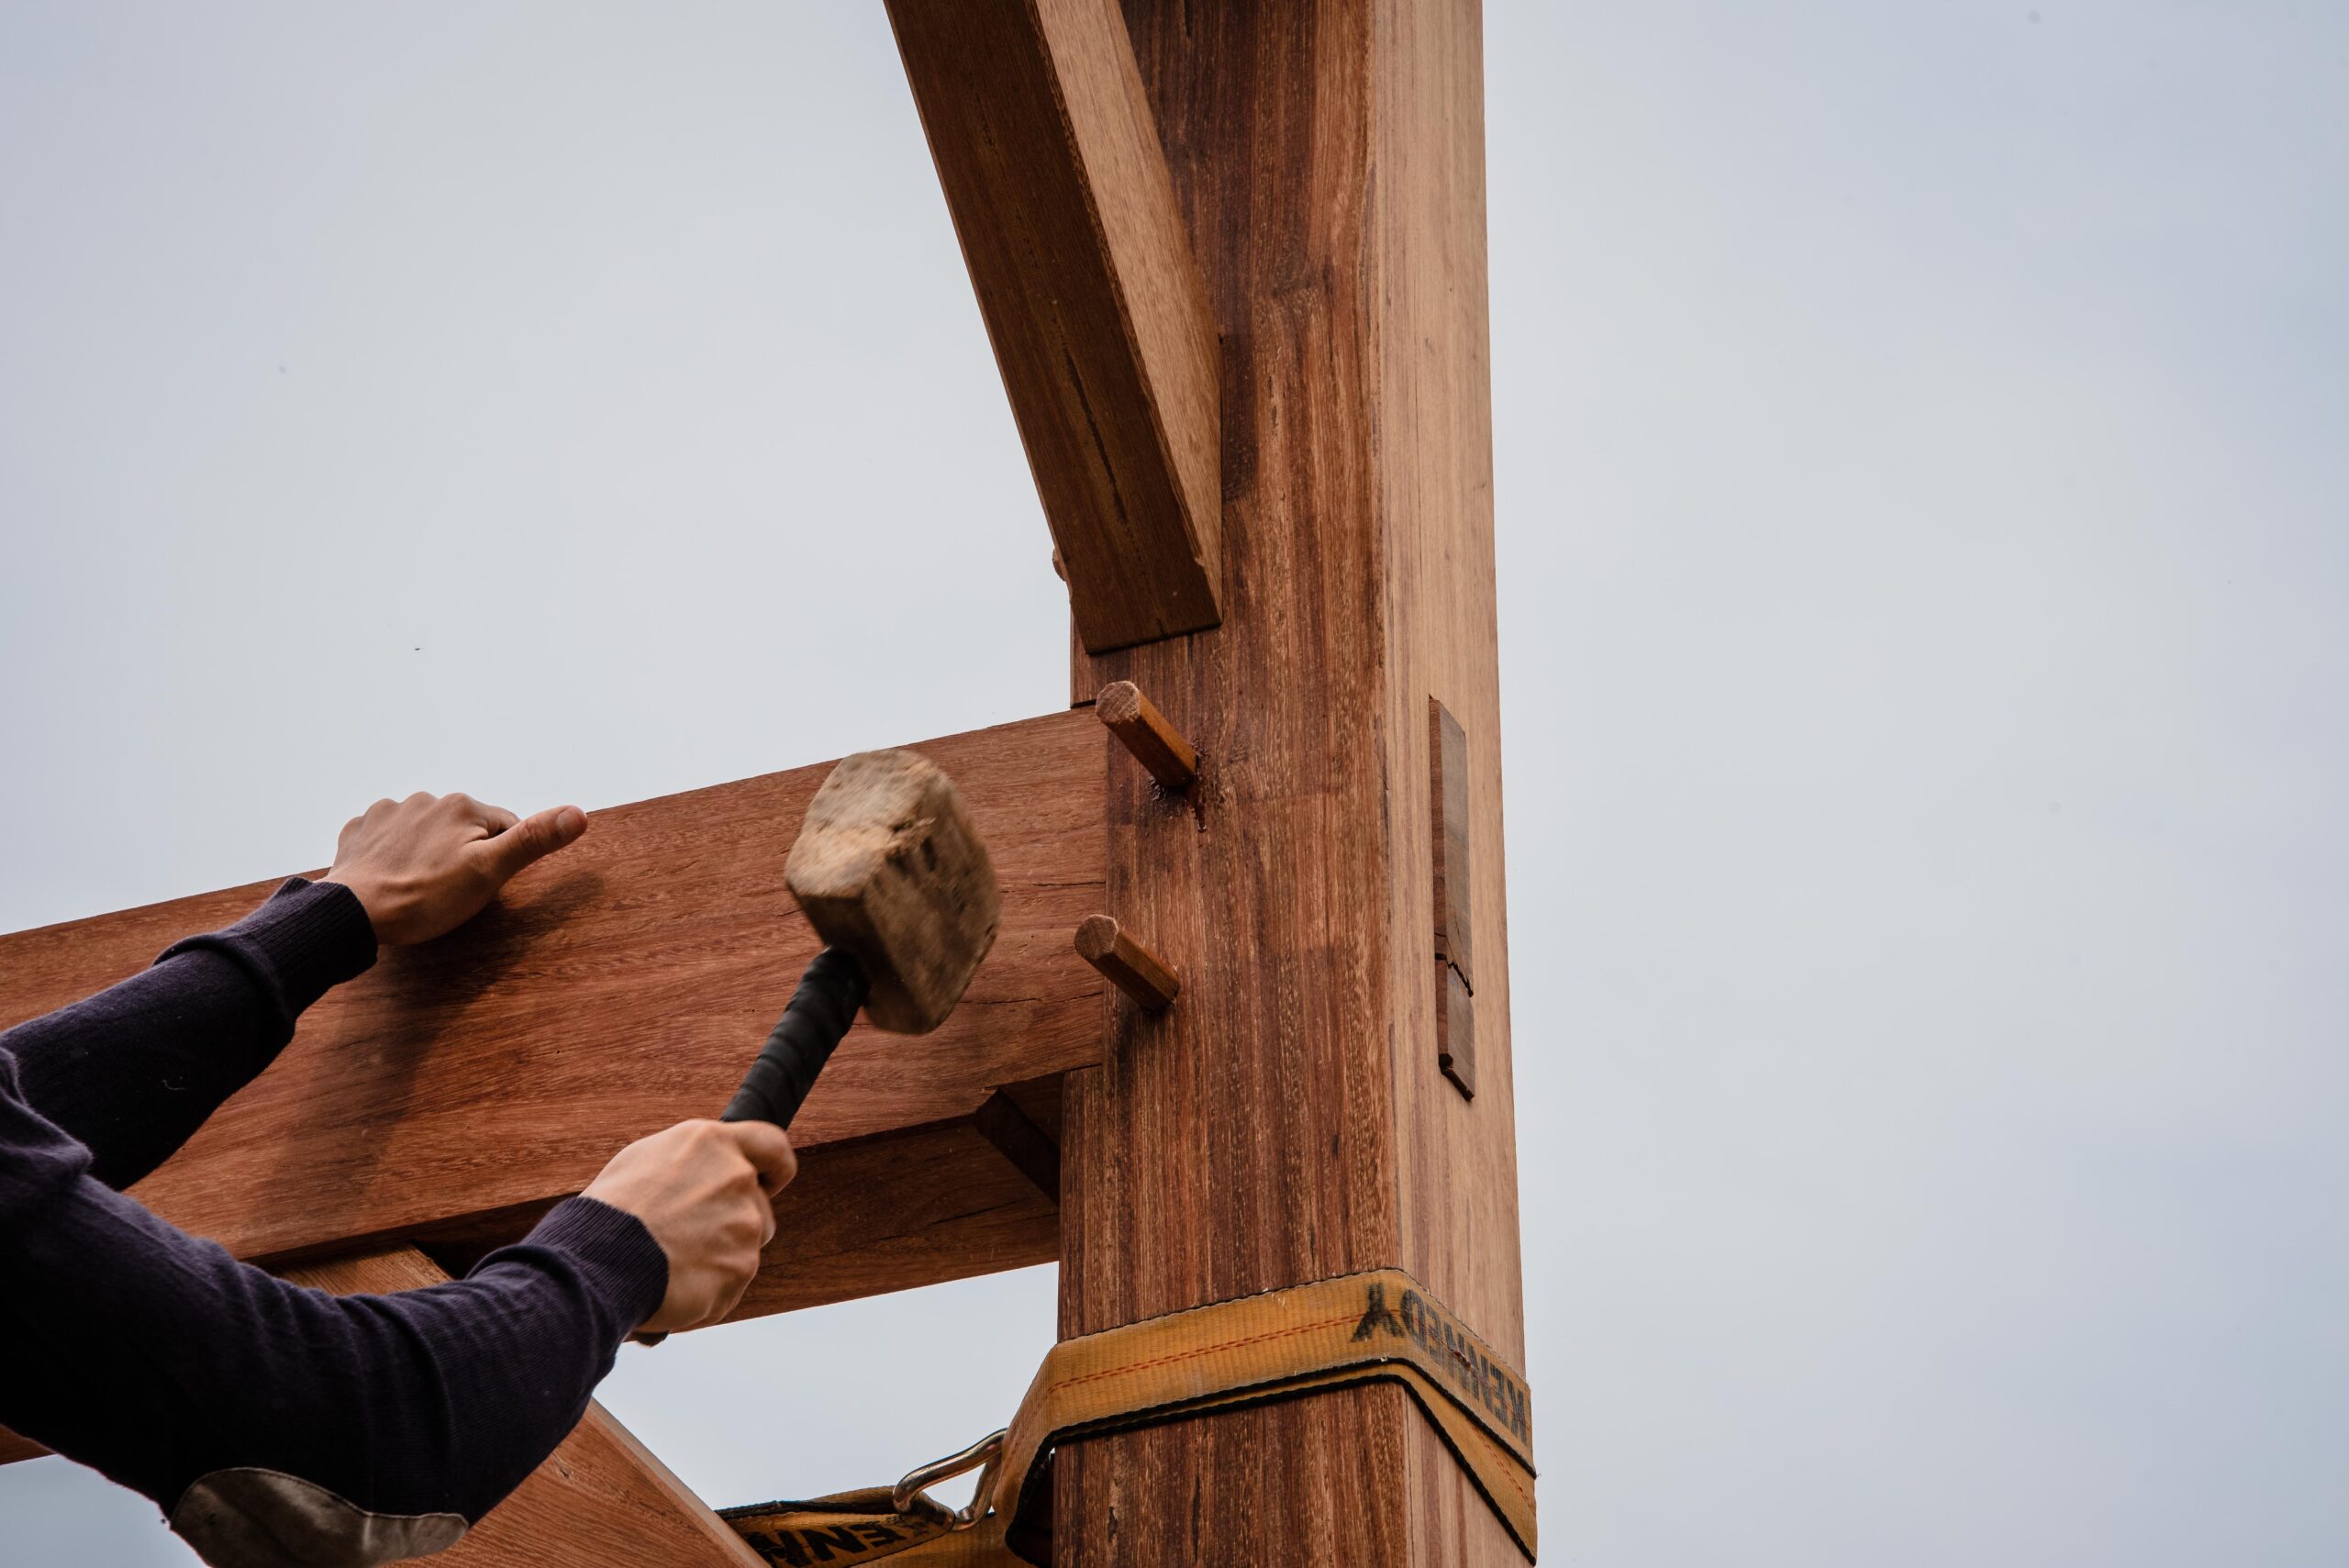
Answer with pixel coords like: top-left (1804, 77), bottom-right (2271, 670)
top-left (0, 878), bottom-right (376, 1188)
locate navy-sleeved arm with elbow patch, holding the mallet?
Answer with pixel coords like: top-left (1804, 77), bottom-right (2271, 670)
top-left (0, 1059), bottom-right (667, 1544)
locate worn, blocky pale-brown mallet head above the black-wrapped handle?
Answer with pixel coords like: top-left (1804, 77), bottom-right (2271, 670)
top-left (782, 749), bottom-right (1003, 1035)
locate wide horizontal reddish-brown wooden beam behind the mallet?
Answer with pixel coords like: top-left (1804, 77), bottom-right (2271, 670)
top-left (0, 714), bottom-right (1104, 1258)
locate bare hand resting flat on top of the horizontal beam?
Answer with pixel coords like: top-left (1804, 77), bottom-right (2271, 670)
top-left (327, 794), bottom-right (587, 946)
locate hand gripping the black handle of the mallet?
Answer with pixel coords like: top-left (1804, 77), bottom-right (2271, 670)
top-left (584, 1122), bottom-right (798, 1336)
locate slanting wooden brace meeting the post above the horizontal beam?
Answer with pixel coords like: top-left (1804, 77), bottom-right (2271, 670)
top-left (888, 0), bottom-right (1221, 651)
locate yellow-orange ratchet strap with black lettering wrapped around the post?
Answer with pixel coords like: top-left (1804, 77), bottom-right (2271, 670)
top-left (723, 1268), bottom-right (1536, 1568)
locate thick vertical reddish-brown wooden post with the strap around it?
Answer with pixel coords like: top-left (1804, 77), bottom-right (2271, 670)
top-left (1054, 0), bottom-right (1524, 1568)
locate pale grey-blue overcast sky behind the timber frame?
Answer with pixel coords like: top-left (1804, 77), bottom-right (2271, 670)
top-left (0, 0), bottom-right (2349, 1568)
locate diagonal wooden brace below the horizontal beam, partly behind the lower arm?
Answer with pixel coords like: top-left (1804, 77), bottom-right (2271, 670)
top-left (286, 1247), bottom-right (763, 1568)
